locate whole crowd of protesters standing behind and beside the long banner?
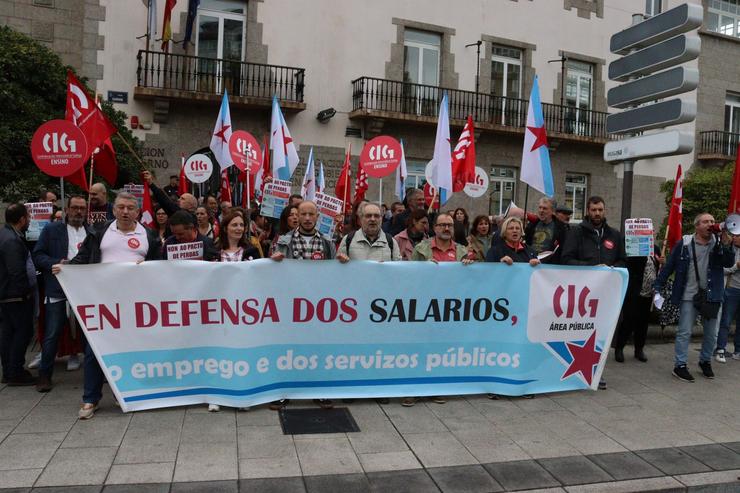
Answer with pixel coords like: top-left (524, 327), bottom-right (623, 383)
top-left (0, 178), bottom-right (740, 419)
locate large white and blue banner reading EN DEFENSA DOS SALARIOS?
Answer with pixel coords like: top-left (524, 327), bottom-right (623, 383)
top-left (59, 259), bottom-right (627, 411)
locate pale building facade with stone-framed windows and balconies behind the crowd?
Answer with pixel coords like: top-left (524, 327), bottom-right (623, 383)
top-left (0, 0), bottom-right (724, 227)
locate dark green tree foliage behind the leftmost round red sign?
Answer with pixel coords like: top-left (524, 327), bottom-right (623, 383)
top-left (0, 27), bottom-right (141, 201)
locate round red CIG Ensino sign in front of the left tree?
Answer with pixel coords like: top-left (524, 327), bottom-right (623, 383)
top-left (31, 120), bottom-right (88, 177)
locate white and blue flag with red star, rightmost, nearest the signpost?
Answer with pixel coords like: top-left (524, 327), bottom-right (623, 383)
top-left (521, 76), bottom-right (555, 197)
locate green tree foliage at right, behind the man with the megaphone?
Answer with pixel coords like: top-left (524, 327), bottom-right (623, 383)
top-left (658, 162), bottom-right (735, 240)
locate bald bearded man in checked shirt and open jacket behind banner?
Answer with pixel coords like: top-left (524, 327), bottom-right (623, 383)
top-left (270, 200), bottom-right (336, 410)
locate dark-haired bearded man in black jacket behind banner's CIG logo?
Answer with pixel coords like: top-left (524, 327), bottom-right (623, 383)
top-left (561, 195), bottom-right (627, 390)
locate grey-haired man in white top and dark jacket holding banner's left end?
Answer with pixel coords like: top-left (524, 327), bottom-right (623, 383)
top-left (51, 192), bottom-right (162, 419)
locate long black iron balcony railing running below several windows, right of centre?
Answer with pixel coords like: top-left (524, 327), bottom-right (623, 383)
top-left (352, 77), bottom-right (607, 140)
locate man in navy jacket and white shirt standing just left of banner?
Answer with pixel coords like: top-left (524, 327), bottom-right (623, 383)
top-left (33, 195), bottom-right (92, 392)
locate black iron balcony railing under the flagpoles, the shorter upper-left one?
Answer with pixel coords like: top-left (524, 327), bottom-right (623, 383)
top-left (136, 50), bottom-right (305, 103)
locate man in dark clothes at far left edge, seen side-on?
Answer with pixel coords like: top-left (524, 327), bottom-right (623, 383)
top-left (0, 204), bottom-right (36, 386)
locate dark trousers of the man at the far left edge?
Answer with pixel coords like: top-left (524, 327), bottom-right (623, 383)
top-left (0, 299), bottom-right (34, 380)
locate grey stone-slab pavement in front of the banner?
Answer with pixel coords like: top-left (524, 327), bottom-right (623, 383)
top-left (0, 344), bottom-right (740, 493)
